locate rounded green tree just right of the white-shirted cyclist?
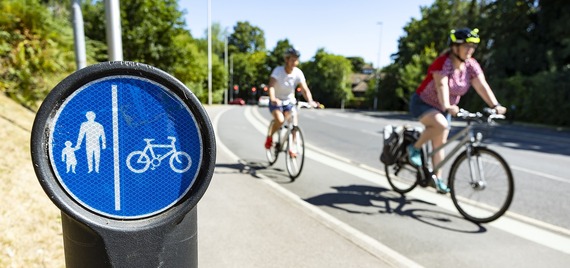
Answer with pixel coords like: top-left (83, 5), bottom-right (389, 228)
top-left (301, 48), bottom-right (352, 107)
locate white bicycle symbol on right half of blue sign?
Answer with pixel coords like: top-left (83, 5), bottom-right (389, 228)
top-left (127, 136), bottom-right (192, 173)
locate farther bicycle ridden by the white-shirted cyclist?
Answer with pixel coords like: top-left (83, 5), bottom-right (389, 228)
top-left (265, 100), bottom-right (305, 181)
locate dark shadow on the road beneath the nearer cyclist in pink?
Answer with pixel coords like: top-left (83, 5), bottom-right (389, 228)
top-left (305, 185), bottom-right (487, 233)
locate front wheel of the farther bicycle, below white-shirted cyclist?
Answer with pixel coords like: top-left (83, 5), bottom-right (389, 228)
top-left (285, 126), bottom-right (305, 180)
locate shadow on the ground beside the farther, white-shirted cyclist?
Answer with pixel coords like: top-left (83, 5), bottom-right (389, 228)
top-left (214, 159), bottom-right (293, 184)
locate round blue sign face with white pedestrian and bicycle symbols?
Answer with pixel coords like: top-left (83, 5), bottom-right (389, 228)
top-left (48, 75), bottom-right (204, 219)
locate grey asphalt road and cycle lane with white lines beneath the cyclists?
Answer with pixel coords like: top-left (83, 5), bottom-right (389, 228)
top-left (215, 106), bottom-right (570, 267)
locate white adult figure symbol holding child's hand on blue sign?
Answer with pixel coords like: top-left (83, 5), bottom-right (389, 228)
top-left (75, 111), bottom-right (107, 173)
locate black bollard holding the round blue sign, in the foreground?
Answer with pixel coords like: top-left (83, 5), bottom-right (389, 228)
top-left (31, 62), bottom-right (216, 268)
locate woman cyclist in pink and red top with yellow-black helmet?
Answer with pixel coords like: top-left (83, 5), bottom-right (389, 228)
top-left (407, 28), bottom-right (507, 193)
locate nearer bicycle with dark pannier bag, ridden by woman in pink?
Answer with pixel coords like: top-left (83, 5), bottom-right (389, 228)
top-left (385, 109), bottom-right (514, 223)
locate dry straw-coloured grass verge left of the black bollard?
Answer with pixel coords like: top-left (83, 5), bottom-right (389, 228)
top-left (0, 95), bottom-right (65, 268)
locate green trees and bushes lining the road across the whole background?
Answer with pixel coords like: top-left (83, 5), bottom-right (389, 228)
top-left (0, 0), bottom-right (570, 127)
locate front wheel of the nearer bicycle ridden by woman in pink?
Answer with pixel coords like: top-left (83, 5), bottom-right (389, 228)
top-left (449, 147), bottom-right (515, 223)
